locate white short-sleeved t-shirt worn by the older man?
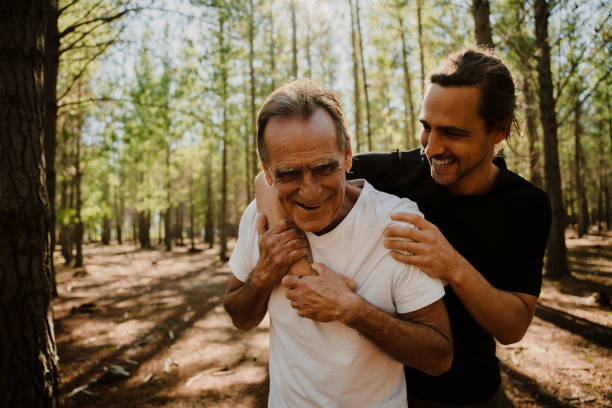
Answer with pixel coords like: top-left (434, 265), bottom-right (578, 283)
top-left (229, 180), bottom-right (444, 408)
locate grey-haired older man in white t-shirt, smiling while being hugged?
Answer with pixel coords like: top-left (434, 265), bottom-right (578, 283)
top-left (225, 81), bottom-right (452, 407)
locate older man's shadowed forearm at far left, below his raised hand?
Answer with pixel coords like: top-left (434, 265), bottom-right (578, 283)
top-left (223, 275), bottom-right (272, 330)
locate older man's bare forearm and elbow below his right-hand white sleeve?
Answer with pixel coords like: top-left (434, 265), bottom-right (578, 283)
top-left (341, 296), bottom-right (453, 375)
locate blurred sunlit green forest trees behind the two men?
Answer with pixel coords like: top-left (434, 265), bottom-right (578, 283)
top-left (47, 0), bottom-right (612, 275)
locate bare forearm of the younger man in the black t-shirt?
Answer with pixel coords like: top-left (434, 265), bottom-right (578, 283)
top-left (449, 260), bottom-right (537, 344)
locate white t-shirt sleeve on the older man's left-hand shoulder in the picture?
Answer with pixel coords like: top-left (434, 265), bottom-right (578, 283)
top-left (228, 201), bottom-right (259, 282)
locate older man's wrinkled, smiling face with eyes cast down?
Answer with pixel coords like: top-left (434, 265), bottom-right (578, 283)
top-left (264, 109), bottom-right (351, 233)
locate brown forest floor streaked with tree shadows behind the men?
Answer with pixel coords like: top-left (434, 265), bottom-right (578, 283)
top-left (54, 232), bottom-right (612, 408)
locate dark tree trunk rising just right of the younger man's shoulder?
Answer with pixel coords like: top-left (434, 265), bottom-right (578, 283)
top-left (534, 0), bottom-right (569, 277)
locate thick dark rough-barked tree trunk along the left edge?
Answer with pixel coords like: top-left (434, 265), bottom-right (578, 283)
top-left (0, 0), bottom-right (60, 408)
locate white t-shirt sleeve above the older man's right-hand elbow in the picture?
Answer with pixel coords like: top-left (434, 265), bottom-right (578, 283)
top-left (393, 265), bottom-right (444, 313)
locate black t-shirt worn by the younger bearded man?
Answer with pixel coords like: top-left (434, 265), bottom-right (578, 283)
top-left (347, 149), bottom-right (551, 404)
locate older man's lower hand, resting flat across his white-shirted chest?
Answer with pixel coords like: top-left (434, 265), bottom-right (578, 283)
top-left (282, 264), bottom-right (362, 322)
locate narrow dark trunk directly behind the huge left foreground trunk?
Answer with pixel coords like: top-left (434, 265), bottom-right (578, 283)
top-left (43, 0), bottom-right (60, 297)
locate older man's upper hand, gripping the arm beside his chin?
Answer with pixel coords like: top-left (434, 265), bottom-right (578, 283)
top-left (251, 214), bottom-right (308, 287)
